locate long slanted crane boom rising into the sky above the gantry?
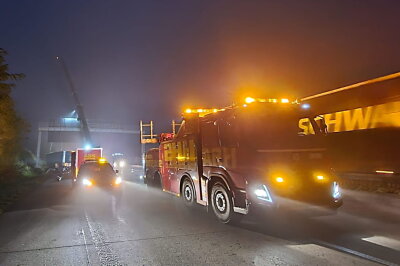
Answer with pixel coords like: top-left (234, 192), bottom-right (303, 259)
top-left (57, 57), bottom-right (93, 147)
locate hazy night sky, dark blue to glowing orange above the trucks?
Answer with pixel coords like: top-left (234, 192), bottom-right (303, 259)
top-left (0, 0), bottom-right (400, 151)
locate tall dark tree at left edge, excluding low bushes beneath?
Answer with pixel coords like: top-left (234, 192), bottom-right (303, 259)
top-left (0, 48), bottom-right (25, 175)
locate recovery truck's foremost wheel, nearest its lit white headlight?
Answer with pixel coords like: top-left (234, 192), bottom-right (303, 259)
top-left (211, 182), bottom-right (235, 224)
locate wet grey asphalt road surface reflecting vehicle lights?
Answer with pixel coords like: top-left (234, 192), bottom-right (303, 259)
top-left (0, 180), bottom-right (400, 265)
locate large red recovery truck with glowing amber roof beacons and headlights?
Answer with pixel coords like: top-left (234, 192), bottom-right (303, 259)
top-left (146, 97), bottom-right (342, 223)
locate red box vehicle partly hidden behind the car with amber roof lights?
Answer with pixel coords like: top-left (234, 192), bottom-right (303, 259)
top-left (71, 148), bottom-right (103, 181)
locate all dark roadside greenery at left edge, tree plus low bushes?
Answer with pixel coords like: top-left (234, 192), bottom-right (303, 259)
top-left (0, 48), bottom-right (43, 213)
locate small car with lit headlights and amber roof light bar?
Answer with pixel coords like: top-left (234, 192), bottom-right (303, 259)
top-left (77, 158), bottom-right (122, 188)
